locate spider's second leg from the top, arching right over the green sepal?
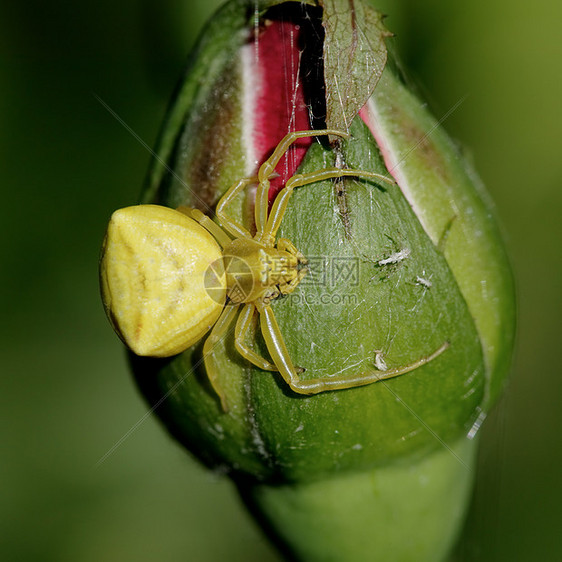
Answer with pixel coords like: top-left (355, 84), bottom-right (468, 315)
top-left (262, 168), bottom-right (394, 240)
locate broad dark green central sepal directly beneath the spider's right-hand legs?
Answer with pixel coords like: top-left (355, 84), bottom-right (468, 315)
top-left (135, 116), bottom-right (485, 481)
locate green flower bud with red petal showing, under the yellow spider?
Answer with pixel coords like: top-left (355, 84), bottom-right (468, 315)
top-left (104, 0), bottom-right (514, 560)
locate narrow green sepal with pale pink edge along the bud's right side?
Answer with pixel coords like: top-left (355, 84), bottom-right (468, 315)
top-left (367, 66), bottom-right (516, 404)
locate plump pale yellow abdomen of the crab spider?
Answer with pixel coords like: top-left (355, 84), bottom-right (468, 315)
top-left (101, 205), bottom-right (226, 357)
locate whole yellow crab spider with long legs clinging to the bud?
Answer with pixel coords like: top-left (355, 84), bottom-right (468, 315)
top-left (100, 129), bottom-right (446, 411)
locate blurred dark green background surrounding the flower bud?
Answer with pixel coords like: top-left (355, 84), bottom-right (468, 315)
top-left (0, 0), bottom-right (562, 562)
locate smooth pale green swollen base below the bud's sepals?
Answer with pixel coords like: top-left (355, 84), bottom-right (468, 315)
top-left (237, 439), bottom-right (478, 562)
